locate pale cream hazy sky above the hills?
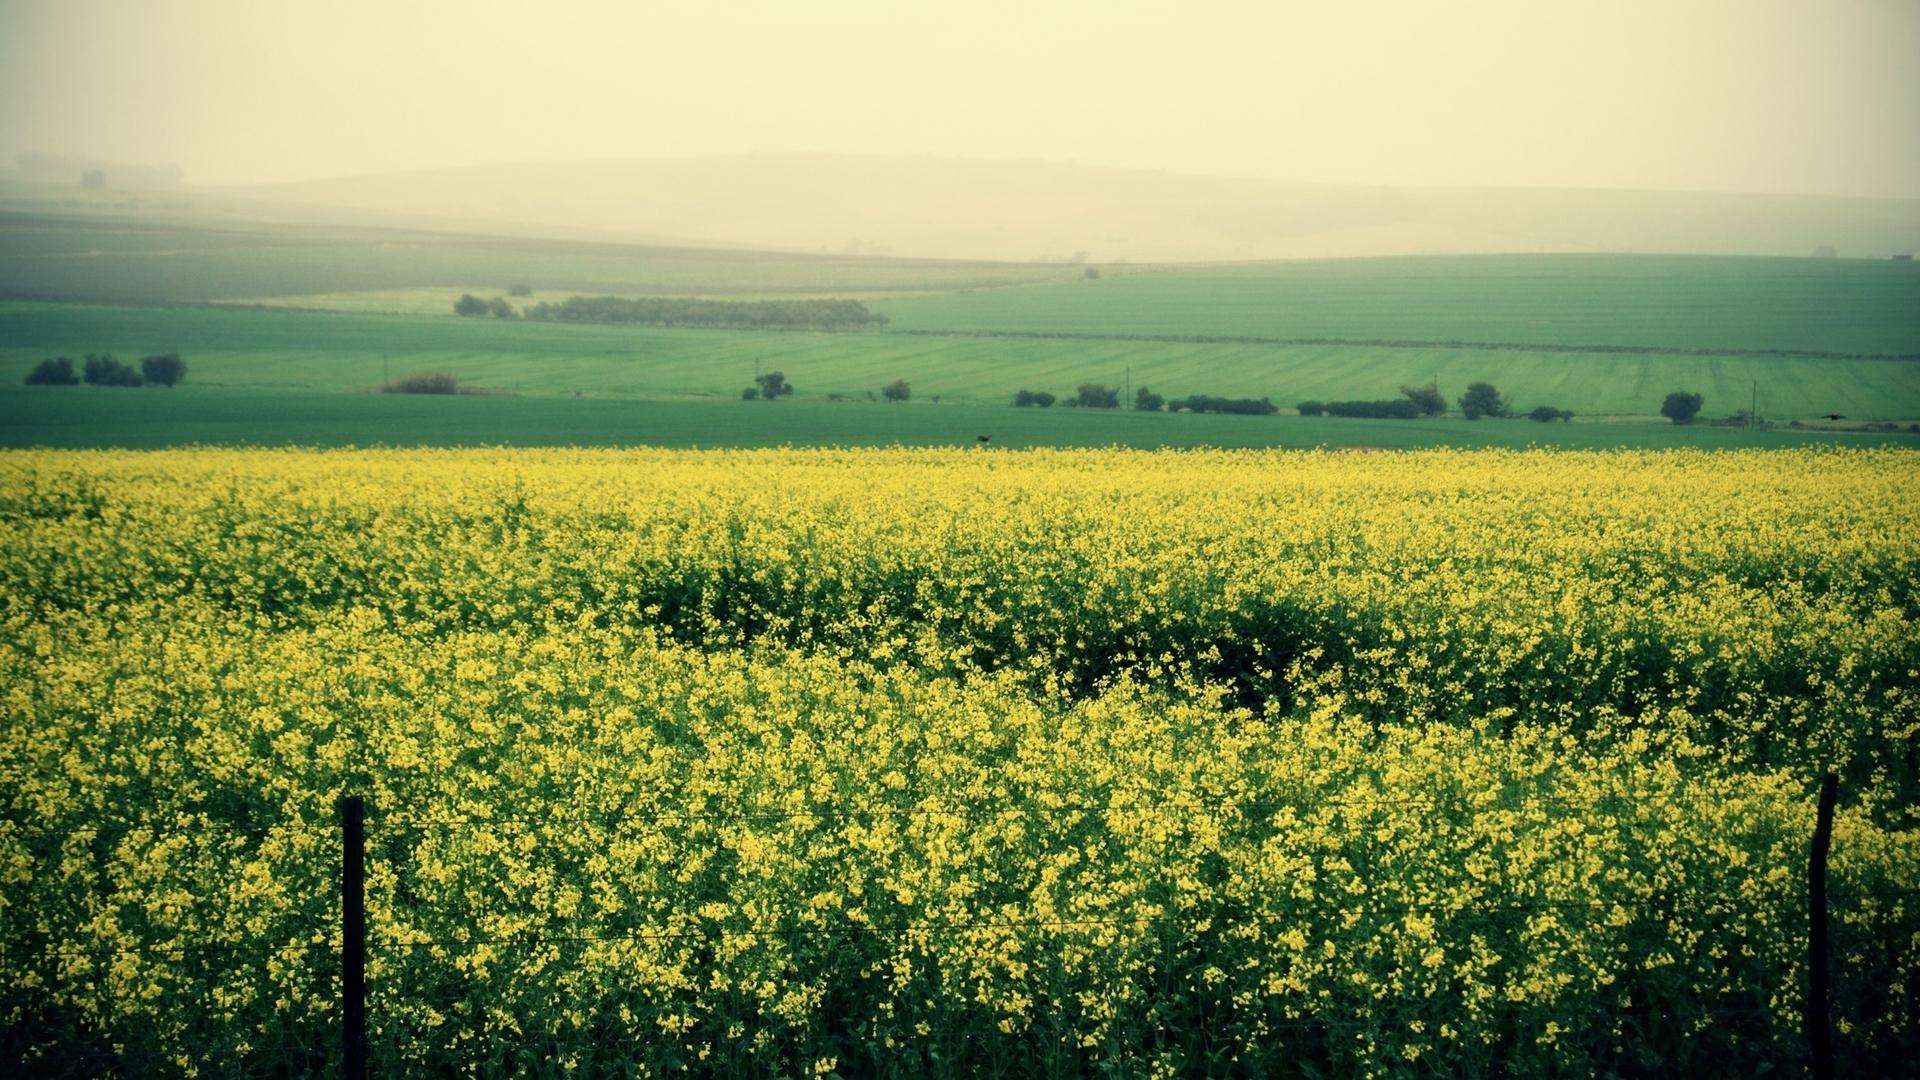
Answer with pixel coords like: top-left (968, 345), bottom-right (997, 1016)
top-left (0, 0), bottom-right (1920, 198)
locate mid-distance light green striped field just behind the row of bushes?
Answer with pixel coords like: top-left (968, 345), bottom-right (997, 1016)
top-left (0, 303), bottom-right (1920, 421)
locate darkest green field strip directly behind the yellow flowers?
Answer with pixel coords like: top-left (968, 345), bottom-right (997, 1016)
top-left (0, 386), bottom-right (1920, 450)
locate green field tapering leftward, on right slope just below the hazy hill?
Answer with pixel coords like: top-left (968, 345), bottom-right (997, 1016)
top-left (881, 256), bottom-right (1920, 356)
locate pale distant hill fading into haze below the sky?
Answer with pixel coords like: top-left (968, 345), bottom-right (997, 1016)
top-left (230, 154), bottom-right (1920, 263)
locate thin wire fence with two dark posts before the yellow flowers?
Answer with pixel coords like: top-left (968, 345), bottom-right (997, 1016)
top-left (0, 778), bottom-right (1901, 1076)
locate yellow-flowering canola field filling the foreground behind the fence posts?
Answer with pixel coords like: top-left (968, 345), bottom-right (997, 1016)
top-left (0, 443), bottom-right (1920, 1074)
